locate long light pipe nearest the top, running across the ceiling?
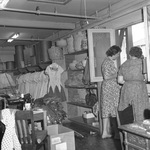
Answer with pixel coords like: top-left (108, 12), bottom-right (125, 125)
top-left (1, 8), bottom-right (98, 20)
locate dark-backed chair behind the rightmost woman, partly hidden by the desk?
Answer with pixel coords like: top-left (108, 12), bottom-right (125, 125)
top-left (116, 104), bottom-right (135, 150)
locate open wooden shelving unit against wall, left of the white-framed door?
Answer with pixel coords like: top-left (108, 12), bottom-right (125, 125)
top-left (65, 50), bottom-right (100, 132)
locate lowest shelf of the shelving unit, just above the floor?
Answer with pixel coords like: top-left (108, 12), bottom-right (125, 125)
top-left (69, 116), bottom-right (100, 132)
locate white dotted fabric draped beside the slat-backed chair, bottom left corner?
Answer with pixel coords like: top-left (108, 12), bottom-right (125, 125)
top-left (1, 109), bottom-right (21, 150)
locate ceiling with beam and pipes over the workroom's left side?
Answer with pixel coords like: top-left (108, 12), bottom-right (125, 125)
top-left (0, 0), bottom-right (121, 47)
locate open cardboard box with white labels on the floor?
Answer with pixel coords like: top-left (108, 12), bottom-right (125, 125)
top-left (47, 124), bottom-right (75, 150)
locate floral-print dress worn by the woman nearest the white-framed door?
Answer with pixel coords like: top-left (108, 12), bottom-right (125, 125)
top-left (101, 58), bottom-right (120, 118)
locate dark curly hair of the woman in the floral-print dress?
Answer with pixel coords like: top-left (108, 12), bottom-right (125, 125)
top-left (106, 45), bottom-right (121, 56)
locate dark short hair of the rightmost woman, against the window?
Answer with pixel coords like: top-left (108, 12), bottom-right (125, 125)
top-left (129, 46), bottom-right (142, 58)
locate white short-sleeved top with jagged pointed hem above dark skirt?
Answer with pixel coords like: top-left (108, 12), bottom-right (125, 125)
top-left (45, 63), bottom-right (64, 92)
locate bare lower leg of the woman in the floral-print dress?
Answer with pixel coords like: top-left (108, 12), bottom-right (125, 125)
top-left (102, 117), bottom-right (111, 138)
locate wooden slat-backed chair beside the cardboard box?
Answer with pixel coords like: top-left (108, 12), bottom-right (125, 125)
top-left (15, 111), bottom-right (47, 150)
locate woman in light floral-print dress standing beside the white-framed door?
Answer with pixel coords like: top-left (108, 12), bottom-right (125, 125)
top-left (101, 45), bottom-right (121, 138)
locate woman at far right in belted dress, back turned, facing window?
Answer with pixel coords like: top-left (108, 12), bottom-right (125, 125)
top-left (118, 46), bottom-right (149, 121)
